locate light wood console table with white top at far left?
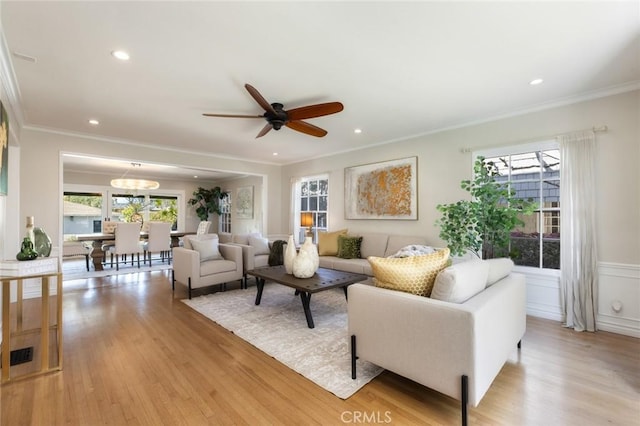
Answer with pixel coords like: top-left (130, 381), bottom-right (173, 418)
top-left (0, 258), bottom-right (62, 383)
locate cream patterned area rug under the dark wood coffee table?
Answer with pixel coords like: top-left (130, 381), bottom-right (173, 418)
top-left (183, 283), bottom-right (383, 399)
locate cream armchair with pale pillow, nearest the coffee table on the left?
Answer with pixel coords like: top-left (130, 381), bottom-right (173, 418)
top-left (172, 234), bottom-right (243, 299)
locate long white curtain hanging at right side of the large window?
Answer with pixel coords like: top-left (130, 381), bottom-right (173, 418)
top-left (558, 132), bottom-right (598, 331)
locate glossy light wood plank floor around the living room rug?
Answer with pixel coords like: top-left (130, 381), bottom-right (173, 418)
top-left (0, 264), bottom-right (640, 426)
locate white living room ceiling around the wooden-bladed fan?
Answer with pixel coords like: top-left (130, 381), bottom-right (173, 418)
top-left (0, 1), bottom-right (640, 180)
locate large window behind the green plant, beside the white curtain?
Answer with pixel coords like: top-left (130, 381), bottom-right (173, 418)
top-left (476, 142), bottom-right (561, 269)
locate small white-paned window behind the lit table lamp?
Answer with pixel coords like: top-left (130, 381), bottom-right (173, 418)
top-left (294, 175), bottom-right (329, 241)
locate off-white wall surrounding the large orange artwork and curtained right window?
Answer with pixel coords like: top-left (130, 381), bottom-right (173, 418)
top-left (281, 91), bottom-right (640, 337)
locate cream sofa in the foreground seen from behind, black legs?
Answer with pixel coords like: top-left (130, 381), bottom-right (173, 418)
top-left (347, 259), bottom-right (526, 424)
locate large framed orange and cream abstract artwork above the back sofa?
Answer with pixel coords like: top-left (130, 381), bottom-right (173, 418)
top-left (344, 157), bottom-right (418, 220)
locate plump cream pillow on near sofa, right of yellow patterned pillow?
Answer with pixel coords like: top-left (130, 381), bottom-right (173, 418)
top-left (431, 260), bottom-right (489, 303)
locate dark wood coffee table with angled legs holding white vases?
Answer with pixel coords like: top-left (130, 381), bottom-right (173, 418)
top-left (247, 266), bottom-right (367, 328)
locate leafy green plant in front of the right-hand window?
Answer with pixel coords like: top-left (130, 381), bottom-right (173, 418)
top-left (436, 157), bottom-right (535, 259)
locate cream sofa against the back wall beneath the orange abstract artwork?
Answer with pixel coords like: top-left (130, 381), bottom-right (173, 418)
top-left (319, 232), bottom-right (427, 277)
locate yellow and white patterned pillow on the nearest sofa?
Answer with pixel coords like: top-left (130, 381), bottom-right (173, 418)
top-left (367, 248), bottom-right (449, 297)
